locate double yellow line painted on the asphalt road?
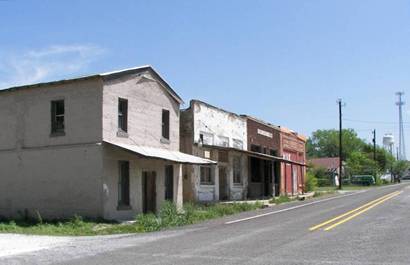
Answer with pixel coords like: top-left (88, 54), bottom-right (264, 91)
top-left (309, 191), bottom-right (402, 231)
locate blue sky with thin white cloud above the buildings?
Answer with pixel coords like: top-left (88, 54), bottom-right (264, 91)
top-left (0, 0), bottom-right (410, 156)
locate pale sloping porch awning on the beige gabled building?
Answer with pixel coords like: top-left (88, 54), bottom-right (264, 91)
top-left (104, 140), bottom-right (217, 165)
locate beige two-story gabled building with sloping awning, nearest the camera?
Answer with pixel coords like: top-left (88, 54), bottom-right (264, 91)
top-left (0, 66), bottom-right (214, 220)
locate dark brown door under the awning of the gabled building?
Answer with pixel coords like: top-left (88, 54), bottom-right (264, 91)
top-left (142, 171), bottom-right (157, 213)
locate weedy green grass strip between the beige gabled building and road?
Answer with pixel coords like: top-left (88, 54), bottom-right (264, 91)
top-left (0, 202), bottom-right (263, 236)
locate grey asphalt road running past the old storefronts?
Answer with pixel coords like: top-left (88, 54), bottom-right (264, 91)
top-left (0, 184), bottom-right (410, 265)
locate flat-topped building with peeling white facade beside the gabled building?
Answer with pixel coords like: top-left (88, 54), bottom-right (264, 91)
top-left (180, 100), bottom-right (248, 202)
